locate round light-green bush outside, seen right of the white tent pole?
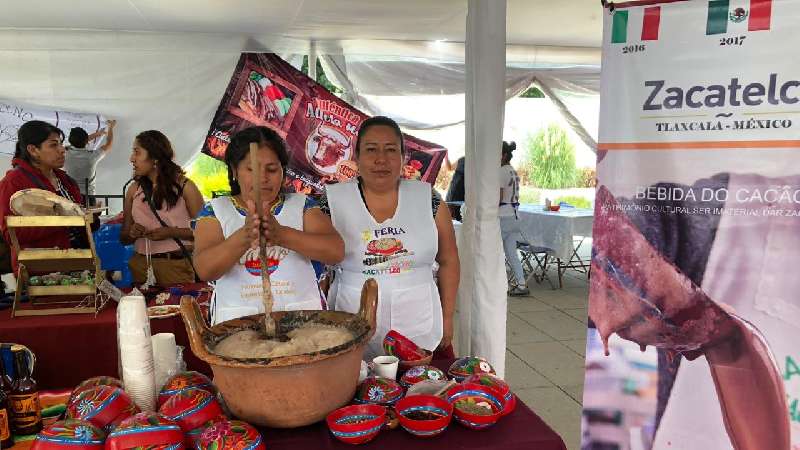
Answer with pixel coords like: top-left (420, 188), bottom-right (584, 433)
top-left (524, 124), bottom-right (578, 189)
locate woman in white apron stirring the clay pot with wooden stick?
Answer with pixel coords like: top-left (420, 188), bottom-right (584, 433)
top-left (194, 127), bottom-right (344, 324)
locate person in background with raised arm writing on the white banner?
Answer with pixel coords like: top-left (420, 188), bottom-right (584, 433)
top-left (64, 120), bottom-right (117, 202)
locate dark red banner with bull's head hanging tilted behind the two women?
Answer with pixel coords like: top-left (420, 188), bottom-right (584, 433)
top-left (203, 53), bottom-right (446, 193)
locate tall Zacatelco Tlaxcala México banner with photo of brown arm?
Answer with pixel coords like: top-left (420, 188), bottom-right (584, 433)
top-left (581, 0), bottom-right (800, 450)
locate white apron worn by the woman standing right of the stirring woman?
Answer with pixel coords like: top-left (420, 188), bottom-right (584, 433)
top-left (327, 180), bottom-right (443, 359)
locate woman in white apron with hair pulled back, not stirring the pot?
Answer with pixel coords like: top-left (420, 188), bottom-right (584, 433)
top-left (320, 117), bottom-right (459, 357)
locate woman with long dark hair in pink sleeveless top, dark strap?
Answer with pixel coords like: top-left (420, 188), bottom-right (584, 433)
top-left (120, 130), bottom-right (203, 286)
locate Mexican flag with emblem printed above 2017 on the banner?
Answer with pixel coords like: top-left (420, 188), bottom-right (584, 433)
top-left (706, 0), bottom-right (772, 35)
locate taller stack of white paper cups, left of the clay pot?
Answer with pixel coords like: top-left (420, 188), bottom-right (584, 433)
top-left (117, 296), bottom-right (156, 411)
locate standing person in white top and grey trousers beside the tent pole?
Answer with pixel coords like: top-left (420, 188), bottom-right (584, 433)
top-left (498, 141), bottom-right (530, 296)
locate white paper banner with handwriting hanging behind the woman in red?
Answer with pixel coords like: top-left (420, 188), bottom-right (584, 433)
top-left (0, 100), bottom-right (106, 155)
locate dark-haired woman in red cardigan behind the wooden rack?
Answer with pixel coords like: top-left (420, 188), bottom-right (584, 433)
top-left (0, 120), bottom-right (88, 271)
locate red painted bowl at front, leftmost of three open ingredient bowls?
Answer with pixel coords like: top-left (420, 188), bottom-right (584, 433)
top-left (326, 405), bottom-right (386, 444)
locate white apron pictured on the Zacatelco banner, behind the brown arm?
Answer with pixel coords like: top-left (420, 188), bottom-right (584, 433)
top-left (653, 175), bottom-right (800, 450)
